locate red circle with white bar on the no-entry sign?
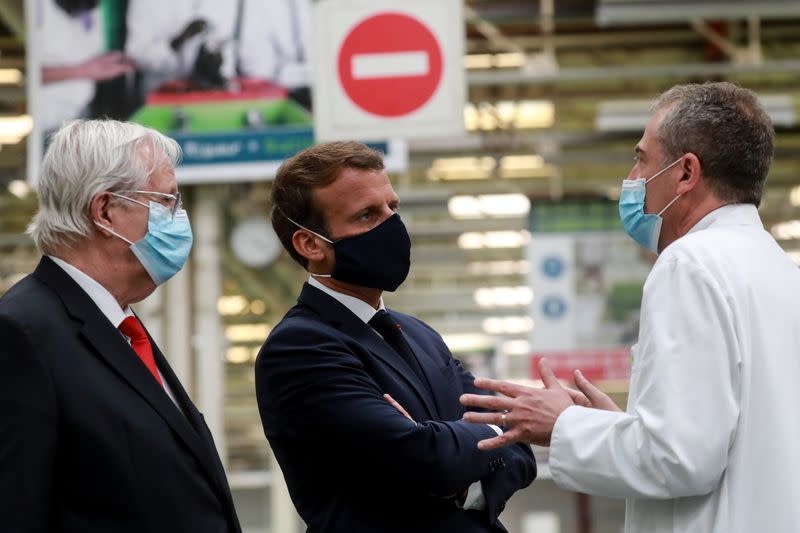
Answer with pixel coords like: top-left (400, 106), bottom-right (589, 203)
top-left (338, 13), bottom-right (442, 118)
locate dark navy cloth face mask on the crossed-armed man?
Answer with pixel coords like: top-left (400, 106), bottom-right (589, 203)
top-left (284, 213), bottom-right (411, 292)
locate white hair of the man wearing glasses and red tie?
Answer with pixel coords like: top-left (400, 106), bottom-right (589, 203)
top-left (28, 120), bottom-right (181, 254)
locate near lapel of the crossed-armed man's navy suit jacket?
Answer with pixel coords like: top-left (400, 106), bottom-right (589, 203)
top-left (297, 283), bottom-right (436, 418)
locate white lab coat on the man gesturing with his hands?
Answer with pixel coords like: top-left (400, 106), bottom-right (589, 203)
top-left (550, 204), bottom-right (800, 533)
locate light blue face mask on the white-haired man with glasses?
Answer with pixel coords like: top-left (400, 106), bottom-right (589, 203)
top-left (95, 193), bottom-right (193, 285)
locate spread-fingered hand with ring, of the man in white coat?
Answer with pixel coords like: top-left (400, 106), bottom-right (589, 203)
top-left (460, 358), bottom-right (577, 450)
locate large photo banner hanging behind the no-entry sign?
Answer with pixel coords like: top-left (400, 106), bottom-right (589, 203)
top-left (26, 0), bottom-right (406, 187)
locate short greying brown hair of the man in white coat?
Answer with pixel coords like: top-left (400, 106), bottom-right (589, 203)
top-left (652, 82), bottom-right (775, 206)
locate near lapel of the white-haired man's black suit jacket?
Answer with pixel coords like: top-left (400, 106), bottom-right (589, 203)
top-left (35, 257), bottom-right (225, 494)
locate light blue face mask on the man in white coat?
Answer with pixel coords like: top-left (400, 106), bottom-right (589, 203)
top-left (619, 156), bottom-right (683, 254)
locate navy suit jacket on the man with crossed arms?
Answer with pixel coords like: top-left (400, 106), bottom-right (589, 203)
top-left (256, 284), bottom-right (536, 533)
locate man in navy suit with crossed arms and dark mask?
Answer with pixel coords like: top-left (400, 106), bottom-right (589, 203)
top-left (255, 142), bottom-right (536, 533)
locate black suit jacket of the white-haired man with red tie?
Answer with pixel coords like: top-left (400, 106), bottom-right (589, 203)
top-left (0, 257), bottom-right (241, 533)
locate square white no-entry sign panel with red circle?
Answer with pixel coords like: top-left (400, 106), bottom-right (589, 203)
top-left (314, 0), bottom-right (465, 140)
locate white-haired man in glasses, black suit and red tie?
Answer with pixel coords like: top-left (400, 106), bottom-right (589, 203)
top-left (0, 120), bottom-right (240, 533)
